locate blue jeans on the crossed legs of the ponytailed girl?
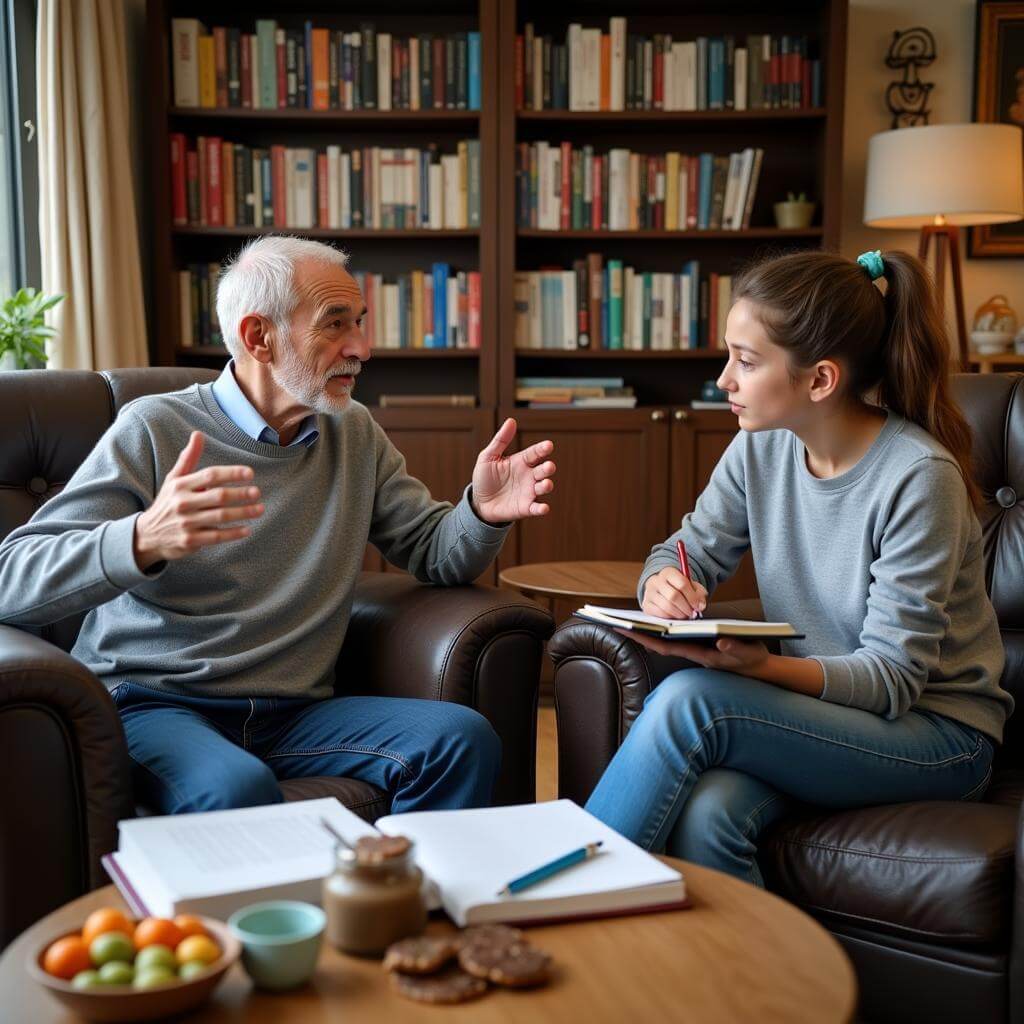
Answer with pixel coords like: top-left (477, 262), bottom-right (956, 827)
top-left (587, 669), bottom-right (993, 885)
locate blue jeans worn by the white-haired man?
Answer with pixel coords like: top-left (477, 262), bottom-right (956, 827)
top-left (113, 683), bottom-right (501, 814)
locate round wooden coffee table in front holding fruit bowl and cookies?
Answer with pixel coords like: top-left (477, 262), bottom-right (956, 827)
top-left (0, 858), bottom-right (856, 1024)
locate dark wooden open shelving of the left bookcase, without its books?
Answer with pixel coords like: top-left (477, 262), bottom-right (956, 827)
top-left (146, 0), bottom-right (498, 415)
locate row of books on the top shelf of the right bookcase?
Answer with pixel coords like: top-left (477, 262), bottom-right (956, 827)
top-left (515, 17), bottom-right (821, 111)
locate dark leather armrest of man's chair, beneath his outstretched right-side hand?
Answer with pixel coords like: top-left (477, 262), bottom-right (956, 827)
top-left (336, 572), bottom-right (554, 803)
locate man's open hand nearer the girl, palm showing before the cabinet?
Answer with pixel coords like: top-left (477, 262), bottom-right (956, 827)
top-left (473, 420), bottom-right (555, 523)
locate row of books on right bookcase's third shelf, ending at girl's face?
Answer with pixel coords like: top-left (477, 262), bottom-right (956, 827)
top-left (513, 253), bottom-right (732, 351)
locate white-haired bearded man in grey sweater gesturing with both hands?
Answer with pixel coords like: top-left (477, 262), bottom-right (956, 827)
top-left (0, 237), bottom-right (555, 813)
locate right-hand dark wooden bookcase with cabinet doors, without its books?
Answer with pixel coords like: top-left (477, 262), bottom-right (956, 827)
top-left (498, 0), bottom-right (847, 606)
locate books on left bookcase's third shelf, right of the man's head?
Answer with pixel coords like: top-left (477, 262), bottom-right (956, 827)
top-left (352, 263), bottom-right (481, 348)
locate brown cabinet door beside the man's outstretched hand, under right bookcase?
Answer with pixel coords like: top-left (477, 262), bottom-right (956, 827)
top-left (500, 409), bottom-right (669, 565)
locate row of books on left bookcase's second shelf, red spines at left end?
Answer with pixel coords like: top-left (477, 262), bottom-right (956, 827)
top-left (170, 132), bottom-right (480, 230)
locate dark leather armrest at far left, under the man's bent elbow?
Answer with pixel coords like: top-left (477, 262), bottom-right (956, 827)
top-left (0, 626), bottom-right (133, 946)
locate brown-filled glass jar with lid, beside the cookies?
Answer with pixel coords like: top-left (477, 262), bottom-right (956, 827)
top-left (324, 836), bottom-right (427, 956)
